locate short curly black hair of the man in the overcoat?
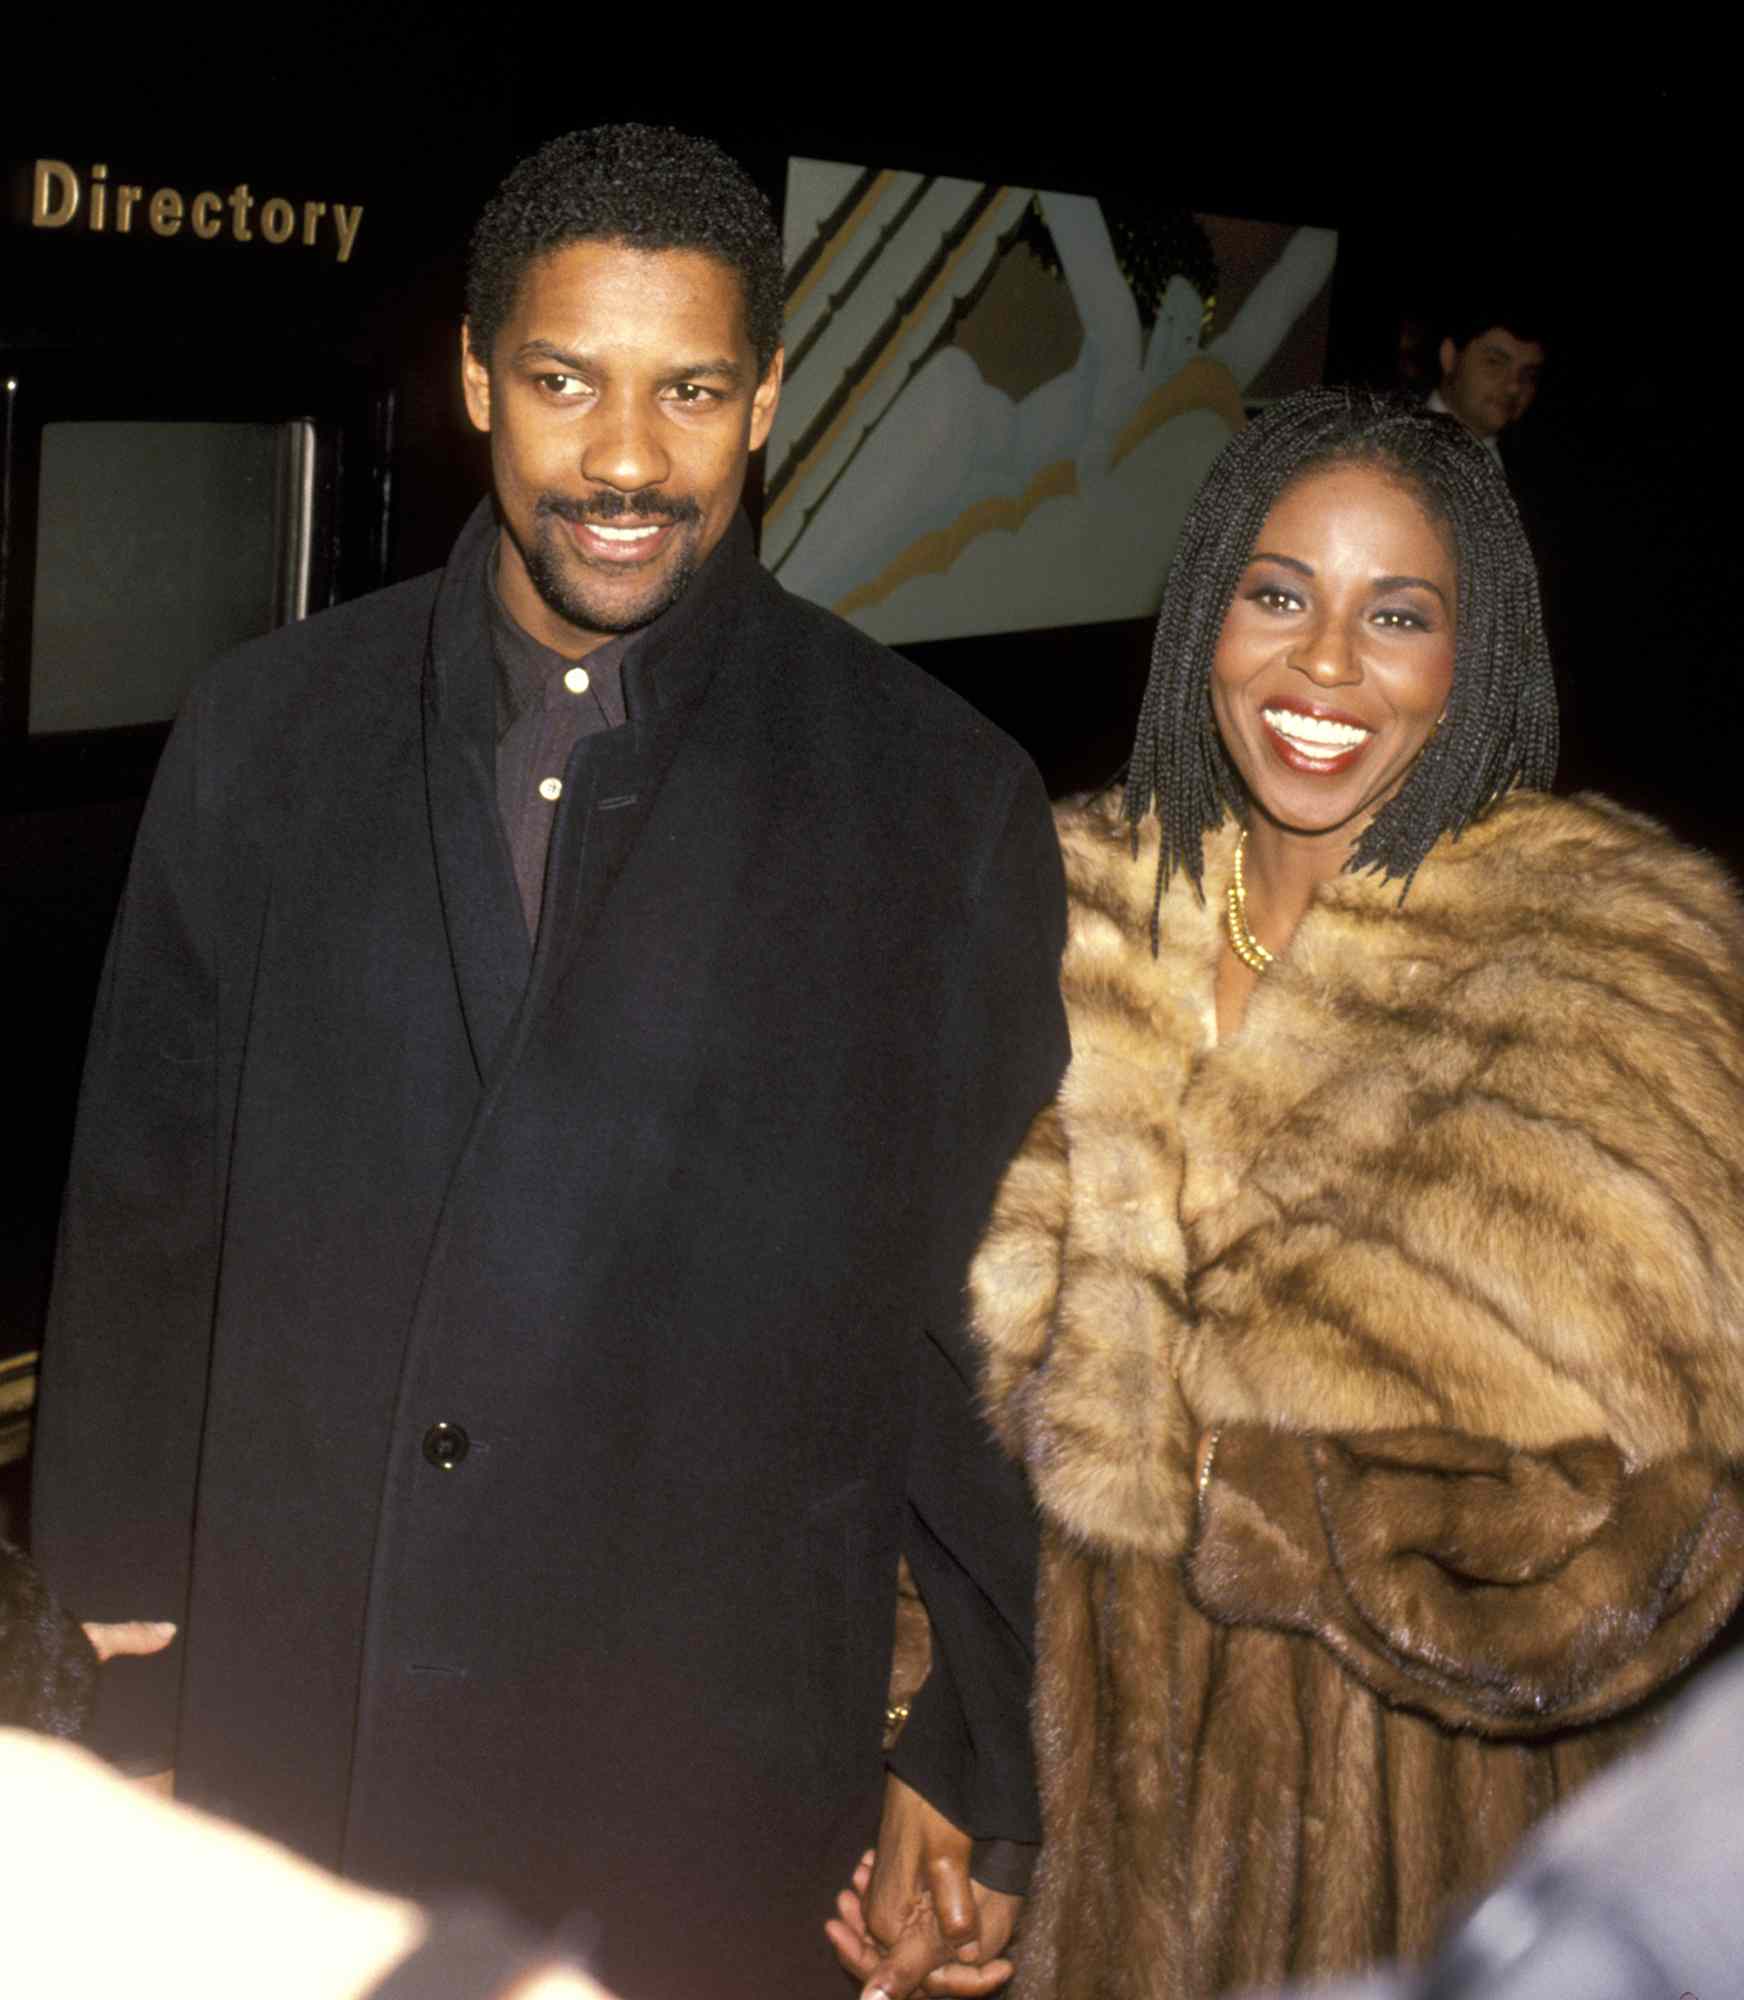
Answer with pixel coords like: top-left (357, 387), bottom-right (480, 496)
top-left (466, 124), bottom-right (782, 376)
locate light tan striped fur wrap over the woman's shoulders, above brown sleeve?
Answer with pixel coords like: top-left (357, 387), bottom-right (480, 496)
top-left (972, 794), bottom-right (1744, 1556)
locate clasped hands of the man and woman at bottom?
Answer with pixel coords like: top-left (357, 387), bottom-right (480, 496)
top-left (824, 1776), bottom-right (1024, 2000)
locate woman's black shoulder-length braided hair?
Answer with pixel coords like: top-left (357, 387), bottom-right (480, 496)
top-left (1126, 390), bottom-right (1556, 928)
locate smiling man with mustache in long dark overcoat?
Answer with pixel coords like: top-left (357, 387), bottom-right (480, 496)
top-left (36, 126), bottom-right (1064, 2000)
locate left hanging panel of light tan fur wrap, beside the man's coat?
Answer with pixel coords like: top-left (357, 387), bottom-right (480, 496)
top-left (970, 808), bottom-right (1202, 1550)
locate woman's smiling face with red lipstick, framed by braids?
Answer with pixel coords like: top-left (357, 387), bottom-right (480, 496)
top-left (1212, 464), bottom-right (1458, 838)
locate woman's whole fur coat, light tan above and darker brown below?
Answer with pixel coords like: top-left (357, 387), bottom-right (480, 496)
top-left (972, 796), bottom-right (1744, 2000)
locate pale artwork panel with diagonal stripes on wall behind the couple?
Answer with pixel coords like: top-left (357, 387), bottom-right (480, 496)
top-left (762, 158), bottom-right (1338, 646)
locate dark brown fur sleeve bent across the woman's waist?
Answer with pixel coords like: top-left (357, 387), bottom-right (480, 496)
top-left (1188, 1428), bottom-right (1744, 1736)
